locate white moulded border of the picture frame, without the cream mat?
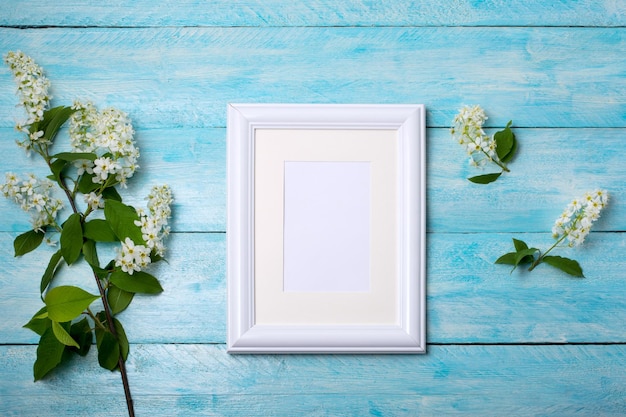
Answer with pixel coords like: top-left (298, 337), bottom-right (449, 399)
top-left (227, 104), bottom-right (426, 353)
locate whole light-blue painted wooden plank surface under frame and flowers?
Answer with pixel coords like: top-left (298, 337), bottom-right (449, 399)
top-left (0, 0), bottom-right (626, 416)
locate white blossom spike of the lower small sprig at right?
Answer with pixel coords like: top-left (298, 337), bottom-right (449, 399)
top-left (552, 189), bottom-right (609, 246)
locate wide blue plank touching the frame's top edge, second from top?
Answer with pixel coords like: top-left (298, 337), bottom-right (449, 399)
top-left (0, 27), bottom-right (626, 128)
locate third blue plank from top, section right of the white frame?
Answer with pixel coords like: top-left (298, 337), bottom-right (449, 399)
top-left (427, 127), bottom-right (626, 233)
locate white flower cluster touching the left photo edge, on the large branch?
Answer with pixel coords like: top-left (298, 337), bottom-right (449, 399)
top-left (0, 172), bottom-right (63, 230)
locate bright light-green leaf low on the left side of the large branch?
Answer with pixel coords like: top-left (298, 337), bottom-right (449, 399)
top-left (44, 285), bottom-right (100, 323)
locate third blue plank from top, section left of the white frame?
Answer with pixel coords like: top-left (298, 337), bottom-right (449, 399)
top-left (0, 125), bottom-right (226, 232)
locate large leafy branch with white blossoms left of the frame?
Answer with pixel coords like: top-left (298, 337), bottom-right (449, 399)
top-left (0, 52), bottom-right (173, 416)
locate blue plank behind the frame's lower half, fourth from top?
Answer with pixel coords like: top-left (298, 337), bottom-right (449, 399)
top-left (0, 233), bottom-right (626, 343)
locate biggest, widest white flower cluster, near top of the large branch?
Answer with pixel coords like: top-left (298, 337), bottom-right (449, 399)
top-left (70, 102), bottom-right (139, 187)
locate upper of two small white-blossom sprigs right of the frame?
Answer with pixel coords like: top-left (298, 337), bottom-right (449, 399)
top-left (450, 105), bottom-right (517, 184)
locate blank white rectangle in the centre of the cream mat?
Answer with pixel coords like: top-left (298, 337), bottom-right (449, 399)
top-left (283, 161), bottom-right (371, 292)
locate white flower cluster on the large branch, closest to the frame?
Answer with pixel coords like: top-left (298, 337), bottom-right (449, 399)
top-left (115, 185), bottom-right (173, 275)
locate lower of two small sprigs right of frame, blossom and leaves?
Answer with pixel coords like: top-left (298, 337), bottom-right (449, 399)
top-left (495, 189), bottom-right (609, 277)
